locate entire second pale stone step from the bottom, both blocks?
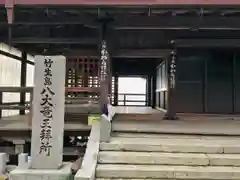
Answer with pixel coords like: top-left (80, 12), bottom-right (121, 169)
top-left (98, 151), bottom-right (240, 166)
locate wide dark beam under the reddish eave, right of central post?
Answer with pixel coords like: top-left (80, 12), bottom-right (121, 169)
top-left (111, 16), bottom-right (240, 30)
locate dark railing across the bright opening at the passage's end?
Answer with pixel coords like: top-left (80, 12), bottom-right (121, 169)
top-left (118, 93), bottom-right (147, 106)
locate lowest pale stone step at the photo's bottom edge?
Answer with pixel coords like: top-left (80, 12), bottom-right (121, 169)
top-left (96, 164), bottom-right (240, 180)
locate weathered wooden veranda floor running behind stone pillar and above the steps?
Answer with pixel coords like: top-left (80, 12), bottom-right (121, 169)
top-left (0, 106), bottom-right (240, 136)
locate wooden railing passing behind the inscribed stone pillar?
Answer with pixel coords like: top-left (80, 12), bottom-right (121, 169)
top-left (0, 87), bottom-right (100, 118)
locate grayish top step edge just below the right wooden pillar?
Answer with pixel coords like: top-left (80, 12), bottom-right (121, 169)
top-left (112, 119), bottom-right (240, 136)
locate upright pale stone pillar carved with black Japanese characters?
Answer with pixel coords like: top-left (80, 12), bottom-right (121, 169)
top-left (31, 56), bottom-right (66, 169)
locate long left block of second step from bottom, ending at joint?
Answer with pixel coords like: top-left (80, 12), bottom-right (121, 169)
top-left (98, 151), bottom-right (209, 166)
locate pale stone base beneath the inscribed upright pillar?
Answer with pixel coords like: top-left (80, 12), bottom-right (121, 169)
top-left (9, 163), bottom-right (73, 180)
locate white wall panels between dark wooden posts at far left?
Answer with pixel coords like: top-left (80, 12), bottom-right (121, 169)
top-left (0, 44), bottom-right (34, 116)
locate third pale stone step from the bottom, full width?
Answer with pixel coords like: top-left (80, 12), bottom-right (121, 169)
top-left (100, 137), bottom-right (240, 154)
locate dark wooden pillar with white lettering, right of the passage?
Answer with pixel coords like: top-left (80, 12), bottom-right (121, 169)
top-left (164, 41), bottom-right (178, 120)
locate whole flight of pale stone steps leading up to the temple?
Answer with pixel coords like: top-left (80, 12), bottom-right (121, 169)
top-left (96, 133), bottom-right (240, 180)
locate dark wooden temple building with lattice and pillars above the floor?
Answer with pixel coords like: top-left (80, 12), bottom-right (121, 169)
top-left (0, 0), bottom-right (240, 134)
